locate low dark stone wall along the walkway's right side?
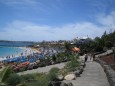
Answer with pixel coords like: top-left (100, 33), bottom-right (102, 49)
top-left (96, 58), bottom-right (115, 86)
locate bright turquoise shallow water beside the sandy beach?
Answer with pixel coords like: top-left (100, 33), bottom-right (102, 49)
top-left (0, 46), bottom-right (23, 57)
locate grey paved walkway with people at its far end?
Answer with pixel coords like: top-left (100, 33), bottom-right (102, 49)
top-left (65, 62), bottom-right (110, 86)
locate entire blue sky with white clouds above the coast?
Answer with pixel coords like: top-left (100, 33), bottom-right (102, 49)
top-left (0, 0), bottom-right (115, 41)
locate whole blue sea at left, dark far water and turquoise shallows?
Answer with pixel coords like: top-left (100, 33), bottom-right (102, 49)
top-left (0, 41), bottom-right (33, 57)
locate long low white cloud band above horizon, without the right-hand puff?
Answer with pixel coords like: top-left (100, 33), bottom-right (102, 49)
top-left (0, 21), bottom-right (103, 41)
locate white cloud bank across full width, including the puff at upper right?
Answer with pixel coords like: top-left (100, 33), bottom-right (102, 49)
top-left (0, 11), bottom-right (115, 41)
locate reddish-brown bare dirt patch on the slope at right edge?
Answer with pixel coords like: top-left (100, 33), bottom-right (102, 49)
top-left (100, 54), bottom-right (115, 70)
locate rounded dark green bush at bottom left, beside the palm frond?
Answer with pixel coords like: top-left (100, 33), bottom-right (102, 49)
top-left (6, 73), bottom-right (21, 86)
